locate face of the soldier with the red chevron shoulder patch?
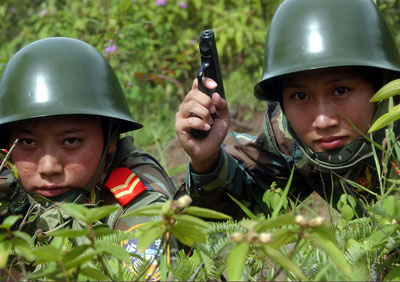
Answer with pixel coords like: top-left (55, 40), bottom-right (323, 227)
top-left (10, 116), bottom-right (104, 197)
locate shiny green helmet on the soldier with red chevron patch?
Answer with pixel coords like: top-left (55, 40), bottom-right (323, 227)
top-left (0, 37), bottom-right (142, 133)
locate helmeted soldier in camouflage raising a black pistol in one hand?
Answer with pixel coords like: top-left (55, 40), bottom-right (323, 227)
top-left (175, 0), bottom-right (400, 218)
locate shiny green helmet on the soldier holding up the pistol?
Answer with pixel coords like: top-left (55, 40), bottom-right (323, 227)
top-left (254, 0), bottom-right (400, 101)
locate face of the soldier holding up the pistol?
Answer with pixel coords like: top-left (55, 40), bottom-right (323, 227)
top-left (283, 67), bottom-right (376, 152)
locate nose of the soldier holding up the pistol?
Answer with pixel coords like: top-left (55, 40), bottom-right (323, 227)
top-left (312, 101), bottom-right (339, 130)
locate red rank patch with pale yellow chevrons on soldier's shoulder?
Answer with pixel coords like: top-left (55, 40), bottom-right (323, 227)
top-left (104, 167), bottom-right (146, 206)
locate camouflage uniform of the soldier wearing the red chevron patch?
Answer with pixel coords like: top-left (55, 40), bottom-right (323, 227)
top-left (1, 136), bottom-right (177, 276)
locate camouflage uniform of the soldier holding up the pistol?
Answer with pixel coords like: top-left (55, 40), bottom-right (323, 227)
top-left (185, 102), bottom-right (400, 219)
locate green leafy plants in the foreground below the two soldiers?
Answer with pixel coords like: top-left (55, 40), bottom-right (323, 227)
top-left (0, 186), bottom-right (400, 281)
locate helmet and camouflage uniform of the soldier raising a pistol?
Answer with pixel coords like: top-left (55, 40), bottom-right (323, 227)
top-left (185, 0), bottom-right (400, 220)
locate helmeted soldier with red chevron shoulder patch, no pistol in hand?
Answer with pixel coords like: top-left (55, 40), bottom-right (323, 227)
top-left (0, 37), bottom-right (176, 276)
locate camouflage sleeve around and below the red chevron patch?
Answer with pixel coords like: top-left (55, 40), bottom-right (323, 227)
top-left (104, 139), bottom-right (178, 281)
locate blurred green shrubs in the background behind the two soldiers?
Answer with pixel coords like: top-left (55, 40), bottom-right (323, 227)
top-left (0, 0), bottom-right (400, 181)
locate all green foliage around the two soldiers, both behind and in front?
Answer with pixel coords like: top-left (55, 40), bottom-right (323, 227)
top-left (0, 0), bottom-right (400, 281)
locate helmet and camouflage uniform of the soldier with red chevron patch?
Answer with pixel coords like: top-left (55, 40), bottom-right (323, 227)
top-left (0, 37), bottom-right (175, 280)
